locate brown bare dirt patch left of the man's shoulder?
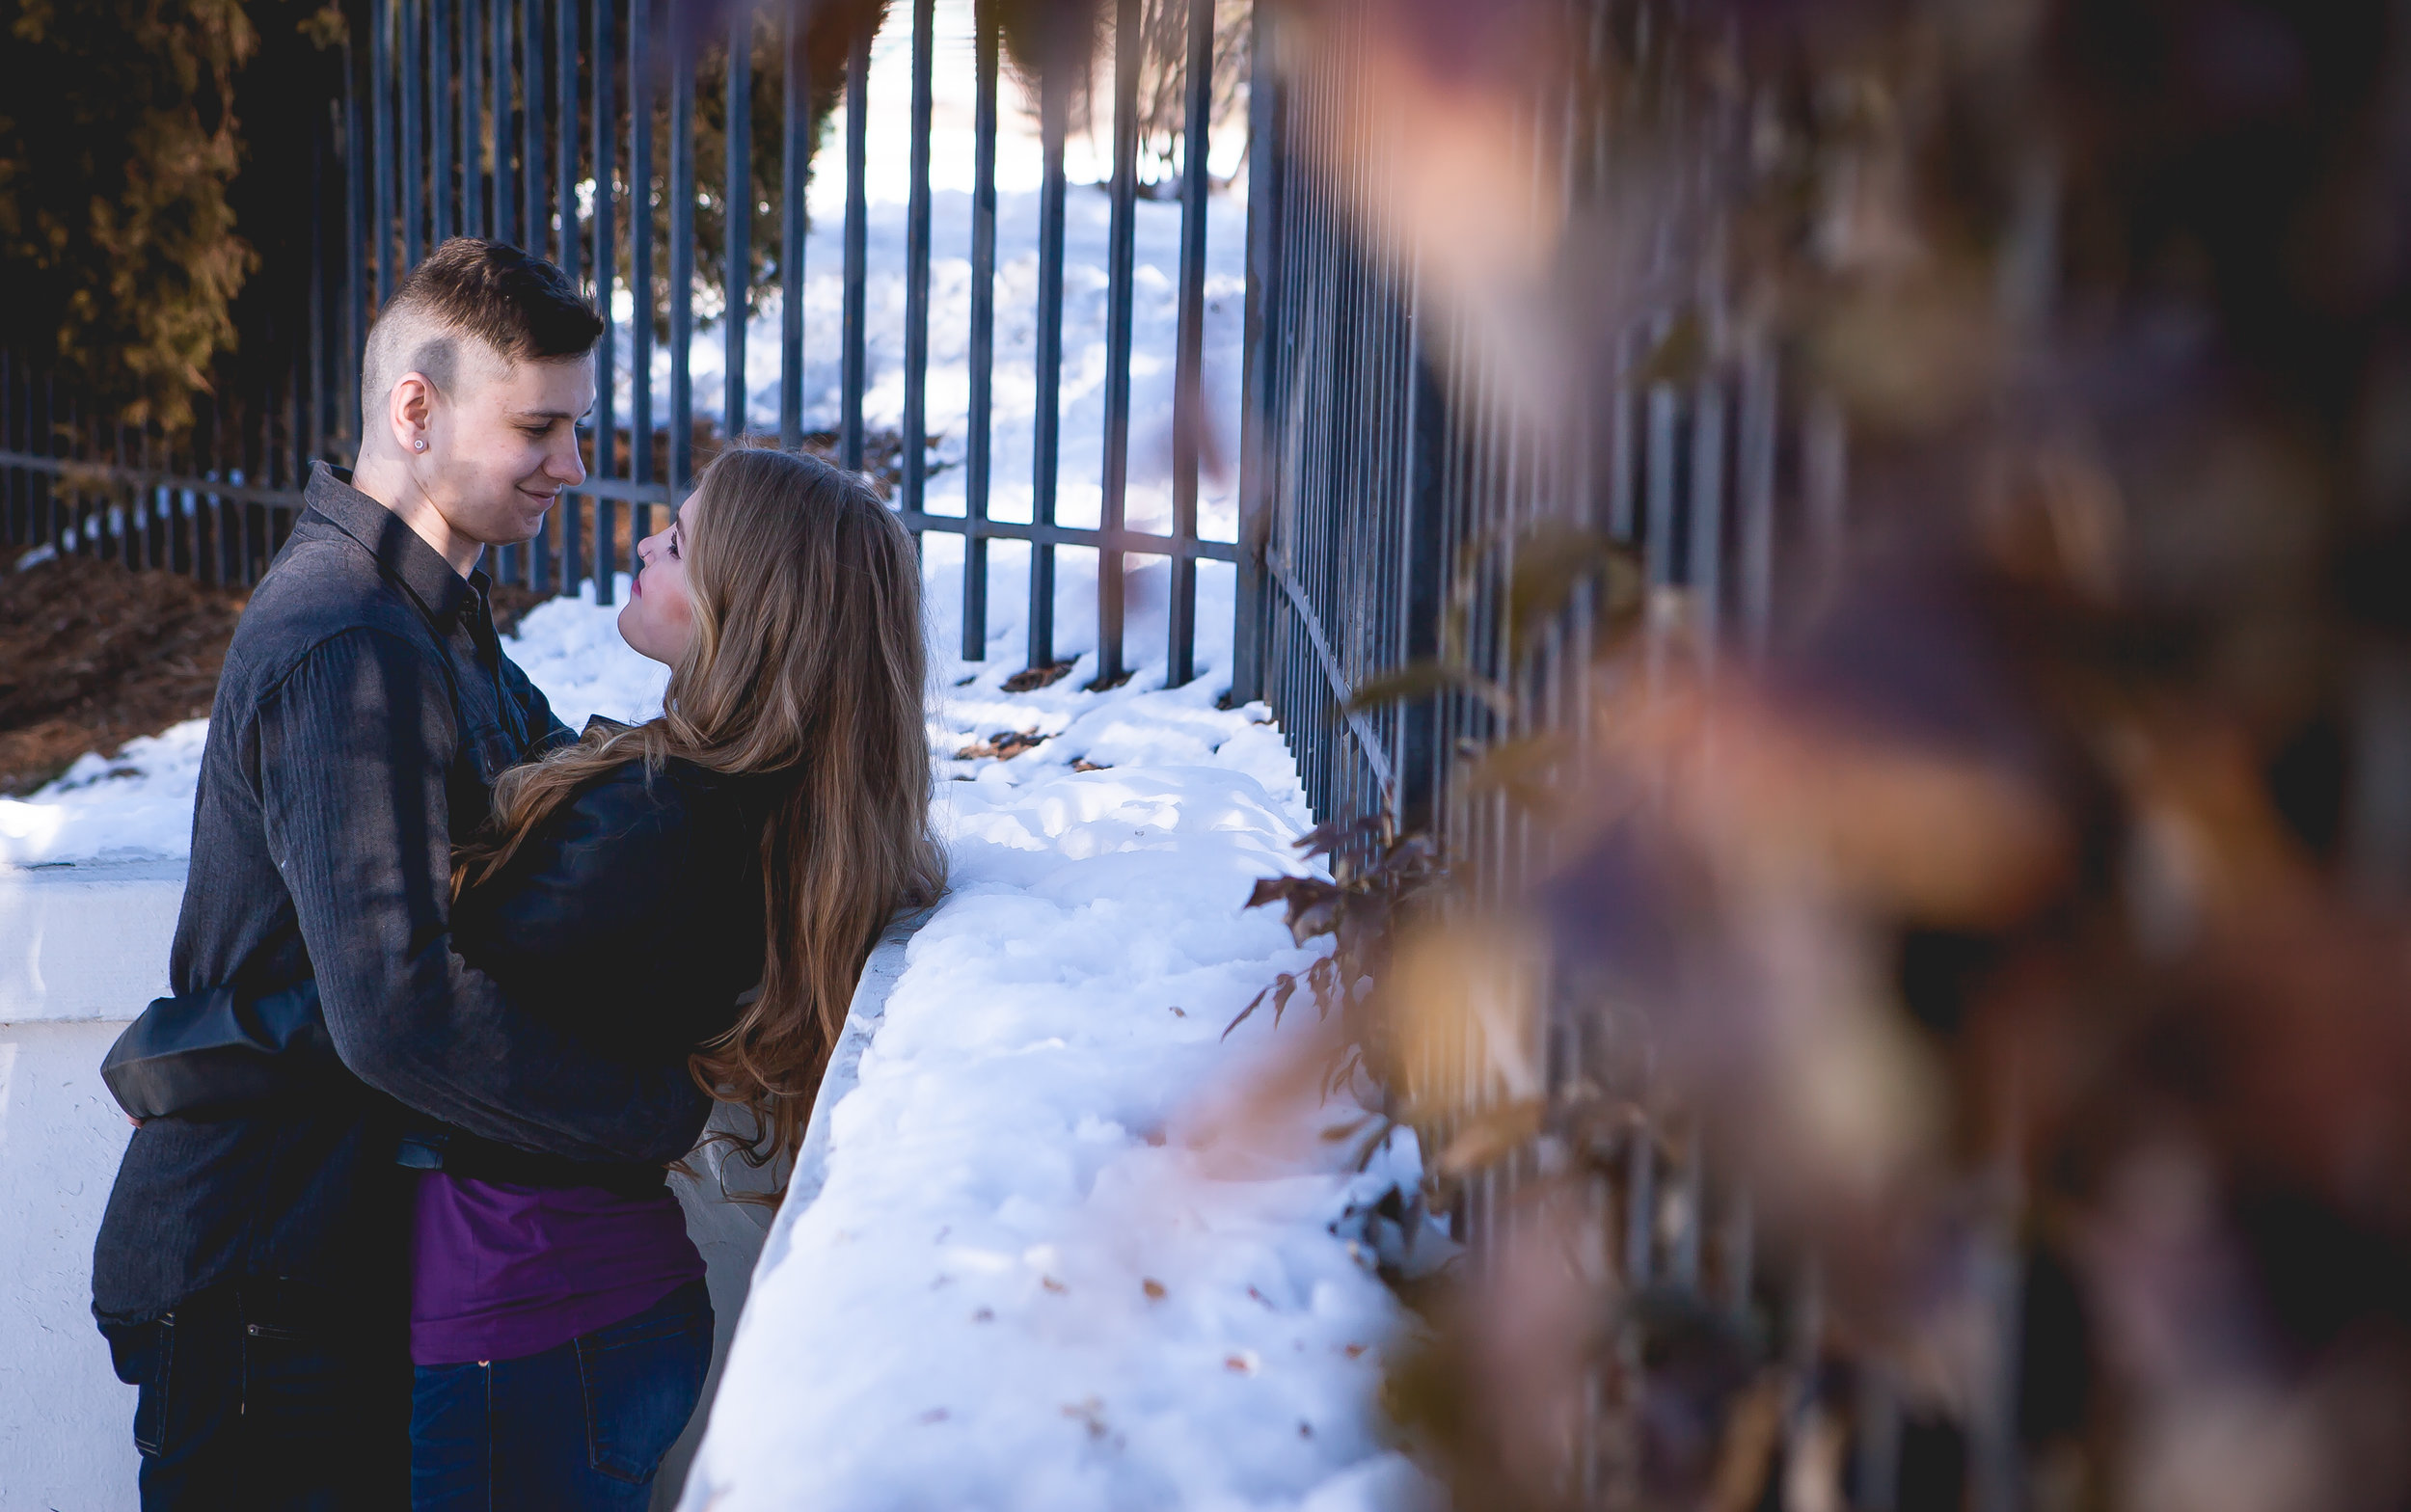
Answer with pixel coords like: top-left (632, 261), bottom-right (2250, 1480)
top-left (0, 557), bottom-right (246, 796)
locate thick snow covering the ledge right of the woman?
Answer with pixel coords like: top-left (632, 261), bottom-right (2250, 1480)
top-left (683, 752), bottom-right (1421, 1512)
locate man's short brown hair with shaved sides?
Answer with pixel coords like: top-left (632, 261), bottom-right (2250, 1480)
top-left (360, 236), bottom-right (603, 415)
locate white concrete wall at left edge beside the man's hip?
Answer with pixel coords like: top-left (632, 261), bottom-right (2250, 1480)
top-left (0, 861), bottom-right (183, 1512)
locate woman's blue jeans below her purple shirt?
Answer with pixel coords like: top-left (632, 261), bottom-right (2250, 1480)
top-left (410, 1281), bottom-right (712, 1512)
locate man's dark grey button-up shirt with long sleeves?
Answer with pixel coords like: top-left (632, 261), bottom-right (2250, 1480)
top-left (92, 466), bottom-right (707, 1321)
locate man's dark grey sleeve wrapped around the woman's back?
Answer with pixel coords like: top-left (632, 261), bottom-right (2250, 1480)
top-left (258, 630), bottom-right (709, 1162)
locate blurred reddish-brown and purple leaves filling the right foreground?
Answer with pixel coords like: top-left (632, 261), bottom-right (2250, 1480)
top-left (1254, 0), bottom-right (2411, 1512)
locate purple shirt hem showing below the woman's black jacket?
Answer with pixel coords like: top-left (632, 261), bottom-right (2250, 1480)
top-left (410, 1172), bottom-right (704, 1364)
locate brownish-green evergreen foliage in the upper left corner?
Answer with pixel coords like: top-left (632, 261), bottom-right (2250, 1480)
top-left (0, 0), bottom-right (345, 432)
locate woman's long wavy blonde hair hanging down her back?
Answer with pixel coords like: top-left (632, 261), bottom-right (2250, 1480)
top-left (453, 448), bottom-right (945, 1181)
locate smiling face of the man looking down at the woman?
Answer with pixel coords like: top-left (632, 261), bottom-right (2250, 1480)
top-left (413, 352), bottom-right (596, 545)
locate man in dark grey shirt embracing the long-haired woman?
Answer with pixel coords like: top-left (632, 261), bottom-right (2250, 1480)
top-left (92, 239), bottom-right (707, 1509)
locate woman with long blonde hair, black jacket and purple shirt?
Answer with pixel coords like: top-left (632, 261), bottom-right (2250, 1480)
top-left (405, 451), bottom-right (943, 1509)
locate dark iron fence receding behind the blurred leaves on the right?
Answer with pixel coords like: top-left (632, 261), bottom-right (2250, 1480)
top-left (1234, 0), bottom-right (2016, 1507)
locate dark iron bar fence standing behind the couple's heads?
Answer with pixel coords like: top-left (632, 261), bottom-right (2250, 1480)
top-left (0, 0), bottom-right (1234, 683)
